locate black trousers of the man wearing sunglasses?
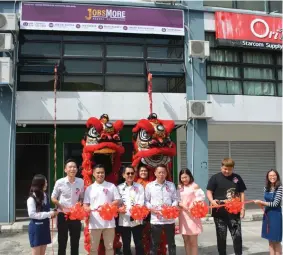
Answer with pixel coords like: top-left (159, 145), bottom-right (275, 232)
top-left (119, 225), bottom-right (144, 255)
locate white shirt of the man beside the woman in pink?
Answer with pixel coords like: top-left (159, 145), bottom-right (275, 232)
top-left (145, 180), bottom-right (178, 224)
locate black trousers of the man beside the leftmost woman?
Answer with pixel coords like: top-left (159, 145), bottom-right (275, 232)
top-left (57, 213), bottom-right (82, 255)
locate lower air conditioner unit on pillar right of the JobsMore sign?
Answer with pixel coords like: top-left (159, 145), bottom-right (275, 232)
top-left (187, 100), bottom-right (212, 119)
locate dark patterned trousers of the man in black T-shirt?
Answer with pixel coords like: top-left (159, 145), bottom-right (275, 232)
top-left (214, 218), bottom-right (243, 255)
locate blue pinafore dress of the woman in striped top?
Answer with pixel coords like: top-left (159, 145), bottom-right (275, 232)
top-left (261, 190), bottom-right (282, 242)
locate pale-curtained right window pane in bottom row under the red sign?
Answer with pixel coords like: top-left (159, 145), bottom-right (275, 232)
top-left (244, 81), bottom-right (275, 96)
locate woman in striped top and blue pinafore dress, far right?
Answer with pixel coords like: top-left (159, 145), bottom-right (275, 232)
top-left (254, 169), bottom-right (282, 255)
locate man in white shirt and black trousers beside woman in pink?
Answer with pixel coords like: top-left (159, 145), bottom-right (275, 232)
top-left (145, 165), bottom-right (178, 255)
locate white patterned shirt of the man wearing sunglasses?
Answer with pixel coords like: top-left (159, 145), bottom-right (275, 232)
top-left (118, 182), bottom-right (144, 227)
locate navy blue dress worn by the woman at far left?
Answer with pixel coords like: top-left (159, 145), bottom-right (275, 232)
top-left (28, 197), bottom-right (51, 247)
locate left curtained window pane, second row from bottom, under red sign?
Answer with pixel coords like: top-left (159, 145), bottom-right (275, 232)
top-left (207, 65), bottom-right (240, 78)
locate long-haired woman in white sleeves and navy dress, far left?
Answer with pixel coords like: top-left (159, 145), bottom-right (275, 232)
top-left (27, 174), bottom-right (57, 255)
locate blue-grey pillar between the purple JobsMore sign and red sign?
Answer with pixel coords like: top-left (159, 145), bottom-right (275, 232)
top-left (185, 9), bottom-right (208, 193)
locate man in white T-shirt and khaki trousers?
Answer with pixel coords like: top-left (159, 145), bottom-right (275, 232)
top-left (84, 164), bottom-right (120, 255)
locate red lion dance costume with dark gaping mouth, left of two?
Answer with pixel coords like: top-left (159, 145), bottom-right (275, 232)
top-left (82, 114), bottom-right (125, 255)
